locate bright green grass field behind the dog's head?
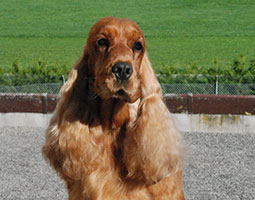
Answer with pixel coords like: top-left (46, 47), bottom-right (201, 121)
top-left (0, 0), bottom-right (255, 69)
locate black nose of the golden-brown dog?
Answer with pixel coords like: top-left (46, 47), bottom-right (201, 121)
top-left (112, 62), bottom-right (133, 81)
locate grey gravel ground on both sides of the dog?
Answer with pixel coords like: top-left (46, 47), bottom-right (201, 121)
top-left (0, 127), bottom-right (255, 200)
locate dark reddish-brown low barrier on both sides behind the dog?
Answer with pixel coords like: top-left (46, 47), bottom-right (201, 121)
top-left (0, 93), bottom-right (255, 115)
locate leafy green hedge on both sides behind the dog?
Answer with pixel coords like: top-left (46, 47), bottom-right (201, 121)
top-left (0, 56), bottom-right (255, 86)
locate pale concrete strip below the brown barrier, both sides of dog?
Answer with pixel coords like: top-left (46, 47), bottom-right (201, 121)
top-left (0, 113), bottom-right (255, 134)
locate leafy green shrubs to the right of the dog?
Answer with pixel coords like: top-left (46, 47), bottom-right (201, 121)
top-left (156, 56), bottom-right (255, 84)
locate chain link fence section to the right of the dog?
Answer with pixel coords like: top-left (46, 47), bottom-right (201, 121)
top-left (157, 75), bottom-right (255, 95)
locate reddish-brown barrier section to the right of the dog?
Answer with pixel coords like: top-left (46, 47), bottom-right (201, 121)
top-left (164, 94), bottom-right (255, 115)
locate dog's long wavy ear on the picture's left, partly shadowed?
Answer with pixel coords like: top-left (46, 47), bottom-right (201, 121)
top-left (43, 48), bottom-right (89, 178)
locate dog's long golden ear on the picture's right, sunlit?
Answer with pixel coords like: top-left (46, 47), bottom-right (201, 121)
top-left (123, 51), bottom-right (182, 184)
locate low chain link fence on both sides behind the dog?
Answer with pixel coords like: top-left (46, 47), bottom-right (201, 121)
top-left (0, 76), bottom-right (255, 95)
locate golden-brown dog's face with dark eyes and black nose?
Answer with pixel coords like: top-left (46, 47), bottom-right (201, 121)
top-left (86, 17), bottom-right (145, 102)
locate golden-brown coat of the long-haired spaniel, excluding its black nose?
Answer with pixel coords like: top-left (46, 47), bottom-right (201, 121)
top-left (43, 17), bottom-right (184, 200)
